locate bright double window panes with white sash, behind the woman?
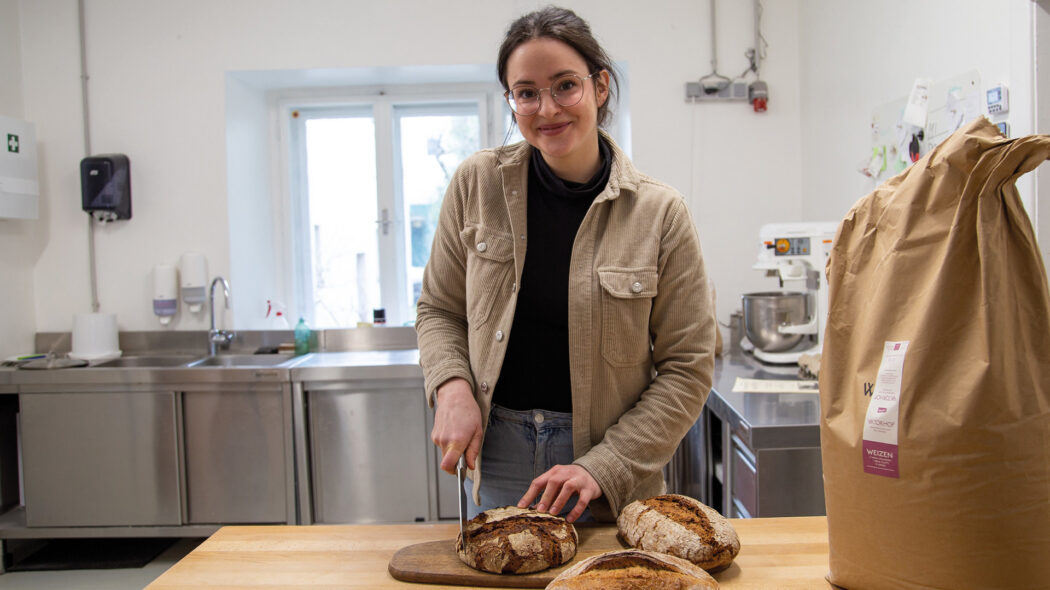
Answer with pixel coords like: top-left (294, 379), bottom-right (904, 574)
top-left (291, 99), bottom-right (482, 328)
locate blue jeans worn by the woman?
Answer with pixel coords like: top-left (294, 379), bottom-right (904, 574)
top-left (463, 405), bottom-right (594, 522)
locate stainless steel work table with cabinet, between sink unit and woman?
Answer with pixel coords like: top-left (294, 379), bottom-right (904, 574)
top-left (291, 350), bottom-right (430, 524)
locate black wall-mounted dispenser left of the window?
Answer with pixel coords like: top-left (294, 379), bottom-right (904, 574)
top-left (80, 153), bottom-right (131, 223)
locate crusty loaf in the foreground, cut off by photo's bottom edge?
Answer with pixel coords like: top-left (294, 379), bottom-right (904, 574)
top-left (547, 549), bottom-right (718, 590)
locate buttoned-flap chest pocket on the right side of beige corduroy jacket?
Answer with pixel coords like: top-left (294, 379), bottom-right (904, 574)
top-left (597, 268), bottom-right (657, 366)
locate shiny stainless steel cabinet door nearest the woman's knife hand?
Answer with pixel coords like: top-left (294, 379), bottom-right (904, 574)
top-left (307, 380), bottom-right (429, 524)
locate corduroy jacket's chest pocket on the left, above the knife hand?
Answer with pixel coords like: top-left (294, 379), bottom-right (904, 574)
top-left (460, 226), bottom-right (515, 330)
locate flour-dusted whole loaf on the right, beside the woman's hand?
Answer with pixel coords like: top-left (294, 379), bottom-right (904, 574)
top-left (616, 493), bottom-right (740, 571)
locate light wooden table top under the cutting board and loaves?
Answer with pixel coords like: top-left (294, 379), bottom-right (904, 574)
top-left (147, 517), bottom-right (832, 590)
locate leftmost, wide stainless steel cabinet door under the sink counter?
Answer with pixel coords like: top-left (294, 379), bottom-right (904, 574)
top-left (19, 392), bottom-right (182, 527)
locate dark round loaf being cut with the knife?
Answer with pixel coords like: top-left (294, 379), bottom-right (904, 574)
top-left (456, 506), bottom-right (580, 573)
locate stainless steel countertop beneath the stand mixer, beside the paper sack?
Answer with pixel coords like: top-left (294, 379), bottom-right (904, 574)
top-left (707, 346), bottom-right (820, 449)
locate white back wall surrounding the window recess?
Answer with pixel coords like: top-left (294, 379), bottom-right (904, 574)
top-left (14, 0), bottom-right (800, 331)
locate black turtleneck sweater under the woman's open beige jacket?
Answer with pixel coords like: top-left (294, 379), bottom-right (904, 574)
top-left (492, 139), bottom-right (612, 413)
